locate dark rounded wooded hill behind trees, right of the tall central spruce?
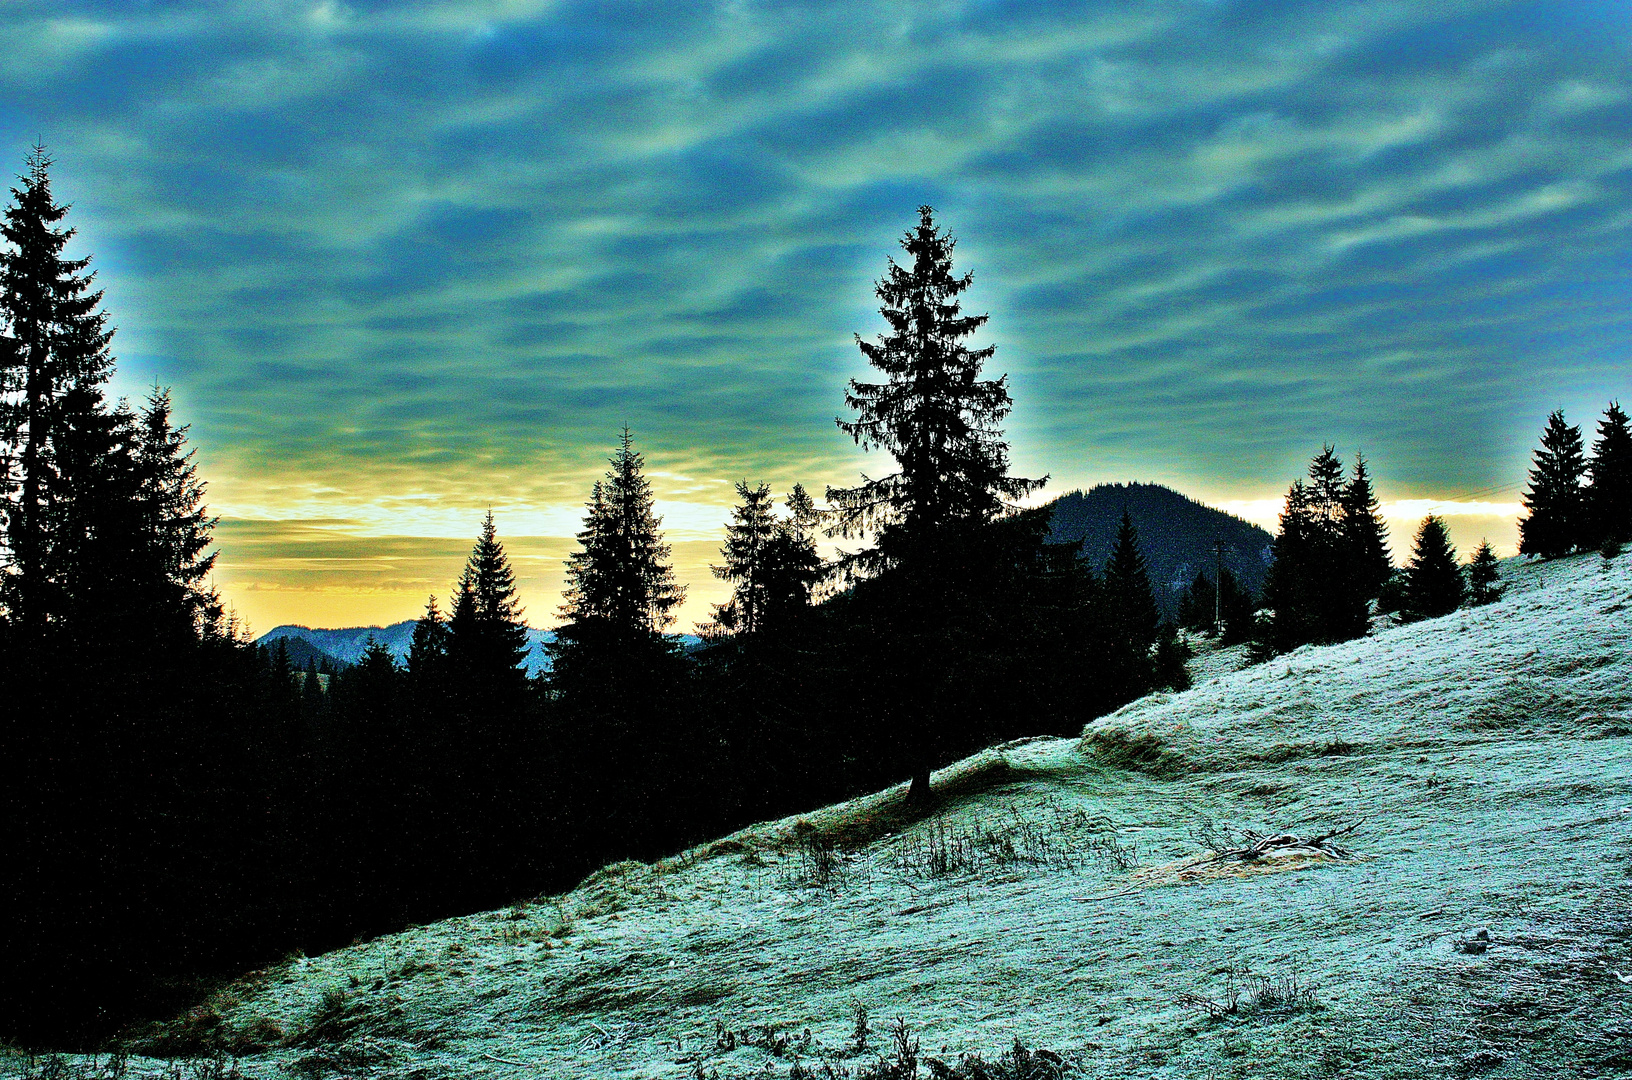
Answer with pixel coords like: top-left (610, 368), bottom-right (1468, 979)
top-left (1049, 483), bottom-right (1275, 618)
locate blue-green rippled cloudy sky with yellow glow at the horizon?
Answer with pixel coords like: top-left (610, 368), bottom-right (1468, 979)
top-left (0, 0), bottom-right (1632, 631)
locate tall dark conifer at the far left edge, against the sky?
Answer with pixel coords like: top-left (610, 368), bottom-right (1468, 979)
top-left (0, 145), bottom-right (113, 630)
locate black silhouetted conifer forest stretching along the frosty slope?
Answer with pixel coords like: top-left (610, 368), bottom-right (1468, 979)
top-left (0, 147), bottom-right (1632, 1046)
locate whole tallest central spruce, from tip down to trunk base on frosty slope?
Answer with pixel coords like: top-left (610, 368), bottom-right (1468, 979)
top-left (827, 206), bottom-right (1043, 806)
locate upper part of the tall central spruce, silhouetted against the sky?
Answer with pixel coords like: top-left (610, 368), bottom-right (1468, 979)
top-left (827, 206), bottom-right (1044, 568)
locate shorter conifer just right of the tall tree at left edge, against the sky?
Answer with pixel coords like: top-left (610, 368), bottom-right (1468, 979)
top-left (135, 387), bottom-right (222, 633)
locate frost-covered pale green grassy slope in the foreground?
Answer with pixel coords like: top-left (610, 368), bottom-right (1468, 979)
top-left (11, 555), bottom-right (1632, 1080)
